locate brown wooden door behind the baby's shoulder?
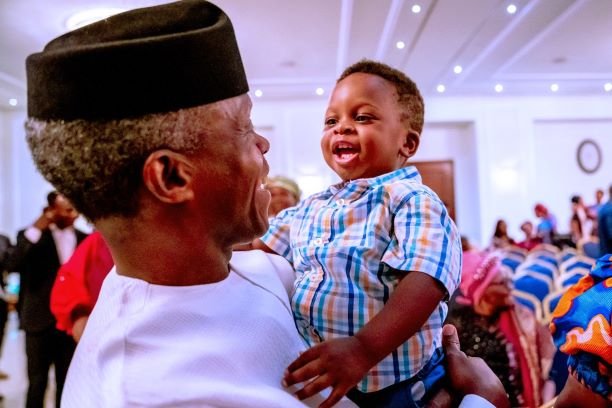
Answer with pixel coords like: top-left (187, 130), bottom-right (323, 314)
top-left (410, 160), bottom-right (457, 222)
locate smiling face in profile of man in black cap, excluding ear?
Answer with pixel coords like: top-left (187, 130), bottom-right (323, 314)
top-left (190, 95), bottom-right (270, 243)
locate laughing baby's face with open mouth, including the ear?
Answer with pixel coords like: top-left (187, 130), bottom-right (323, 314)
top-left (321, 73), bottom-right (418, 181)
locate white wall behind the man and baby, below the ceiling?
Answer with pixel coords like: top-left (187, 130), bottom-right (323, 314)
top-left (0, 95), bottom-right (612, 249)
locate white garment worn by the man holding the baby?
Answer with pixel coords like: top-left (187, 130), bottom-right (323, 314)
top-left (62, 251), bottom-right (353, 408)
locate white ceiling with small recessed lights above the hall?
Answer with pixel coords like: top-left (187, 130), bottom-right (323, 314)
top-left (0, 0), bottom-right (612, 109)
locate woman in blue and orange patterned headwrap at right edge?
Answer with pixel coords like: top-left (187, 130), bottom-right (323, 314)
top-left (550, 254), bottom-right (612, 408)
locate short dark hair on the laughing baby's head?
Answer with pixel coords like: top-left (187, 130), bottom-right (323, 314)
top-left (336, 59), bottom-right (425, 135)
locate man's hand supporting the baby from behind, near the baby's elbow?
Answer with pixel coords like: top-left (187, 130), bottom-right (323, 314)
top-left (434, 324), bottom-right (510, 408)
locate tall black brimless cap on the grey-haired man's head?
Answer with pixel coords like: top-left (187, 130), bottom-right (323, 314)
top-left (26, 0), bottom-right (249, 120)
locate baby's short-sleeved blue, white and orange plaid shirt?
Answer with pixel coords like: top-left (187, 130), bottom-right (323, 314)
top-left (262, 166), bottom-right (461, 392)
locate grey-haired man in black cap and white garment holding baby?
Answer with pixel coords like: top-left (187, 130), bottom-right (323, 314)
top-left (26, 0), bottom-right (354, 407)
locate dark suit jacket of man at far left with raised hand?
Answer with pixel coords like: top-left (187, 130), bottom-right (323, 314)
top-left (9, 229), bottom-right (87, 332)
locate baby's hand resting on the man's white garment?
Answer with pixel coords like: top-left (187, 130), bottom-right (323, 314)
top-left (283, 337), bottom-right (377, 408)
